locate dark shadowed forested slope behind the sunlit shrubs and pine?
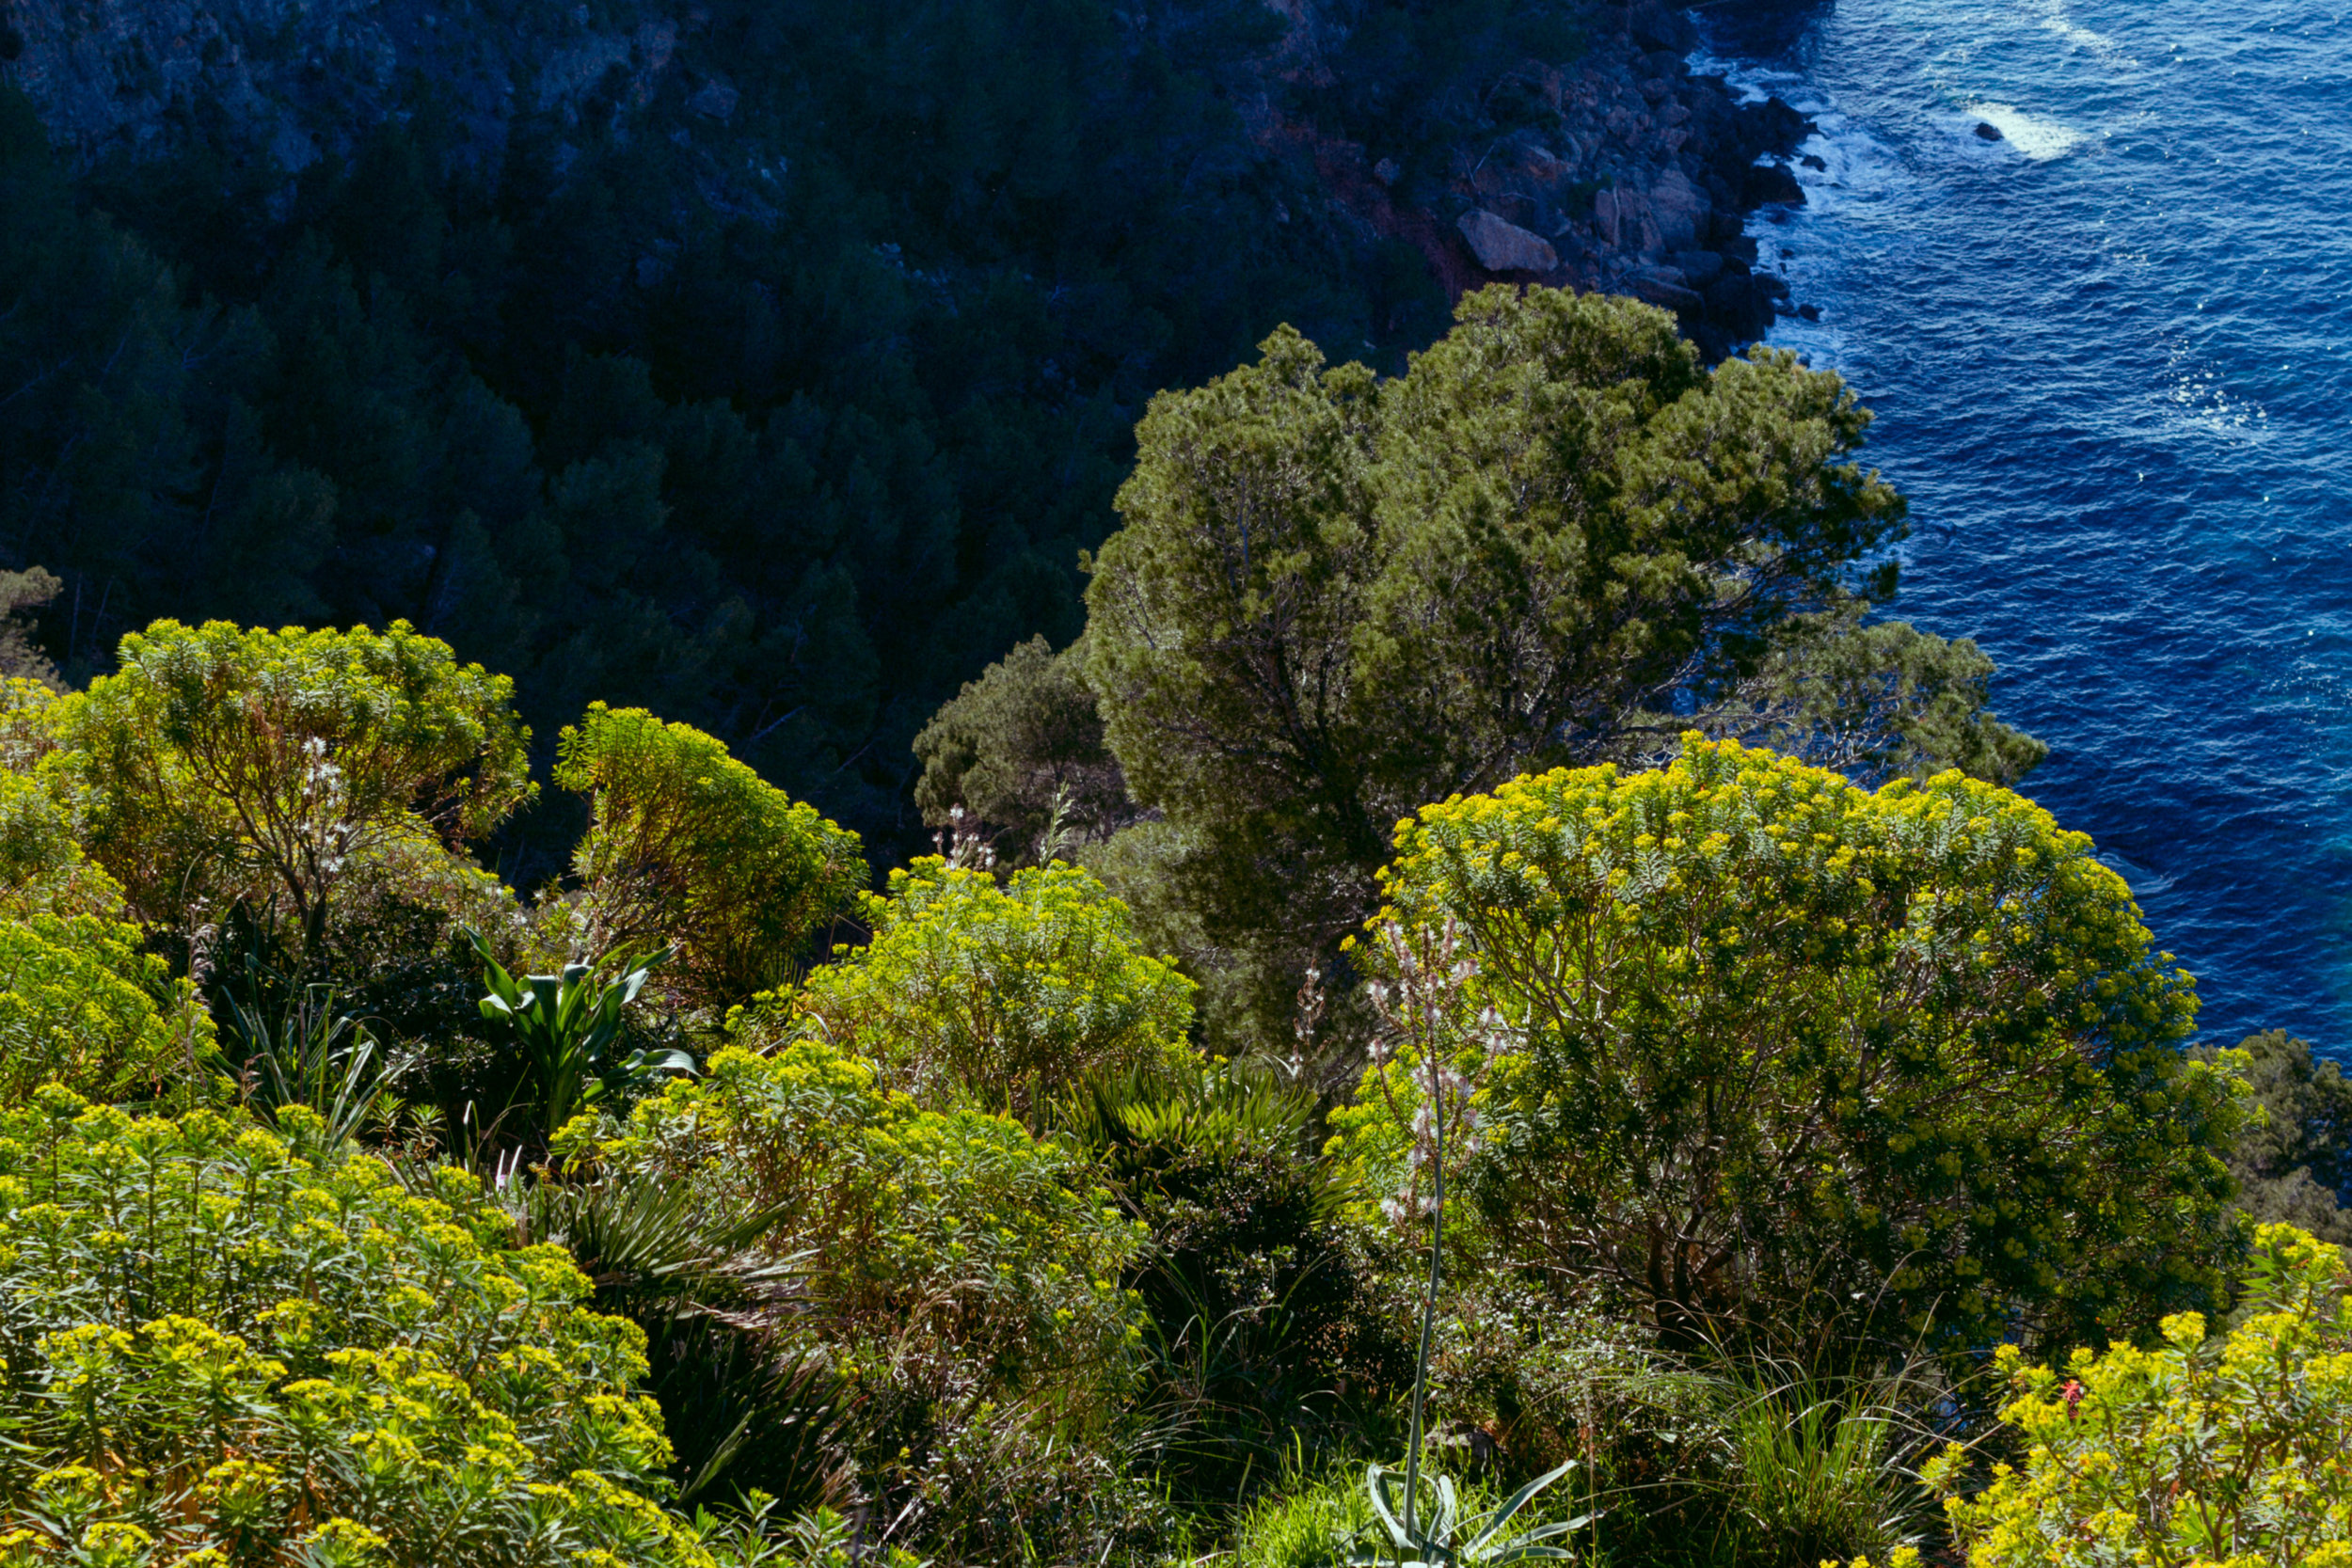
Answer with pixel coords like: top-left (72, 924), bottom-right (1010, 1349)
top-left (0, 0), bottom-right (1790, 858)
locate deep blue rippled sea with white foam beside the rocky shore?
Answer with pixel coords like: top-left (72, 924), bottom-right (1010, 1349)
top-left (1698, 0), bottom-right (2352, 1060)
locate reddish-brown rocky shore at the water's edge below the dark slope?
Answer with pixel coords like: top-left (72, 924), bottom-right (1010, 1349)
top-left (1301, 0), bottom-right (1814, 359)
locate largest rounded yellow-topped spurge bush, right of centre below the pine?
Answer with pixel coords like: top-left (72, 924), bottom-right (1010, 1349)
top-left (1334, 736), bottom-right (2244, 1352)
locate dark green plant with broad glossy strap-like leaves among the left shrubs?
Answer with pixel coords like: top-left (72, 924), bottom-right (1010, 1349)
top-left (469, 931), bottom-right (694, 1138)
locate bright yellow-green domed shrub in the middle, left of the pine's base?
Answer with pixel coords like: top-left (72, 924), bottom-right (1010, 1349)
top-left (793, 856), bottom-right (1193, 1119)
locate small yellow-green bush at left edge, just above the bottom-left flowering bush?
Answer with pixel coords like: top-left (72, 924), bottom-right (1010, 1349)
top-left (0, 914), bottom-right (215, 1102)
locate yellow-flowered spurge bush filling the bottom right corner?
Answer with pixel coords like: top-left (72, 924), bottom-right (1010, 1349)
top-left (1927, 1225), bottom-right (2352, 1568)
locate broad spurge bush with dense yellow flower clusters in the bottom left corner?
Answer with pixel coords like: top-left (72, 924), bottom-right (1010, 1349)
top-left (0, 1086), bottom-right (715, 1568)
